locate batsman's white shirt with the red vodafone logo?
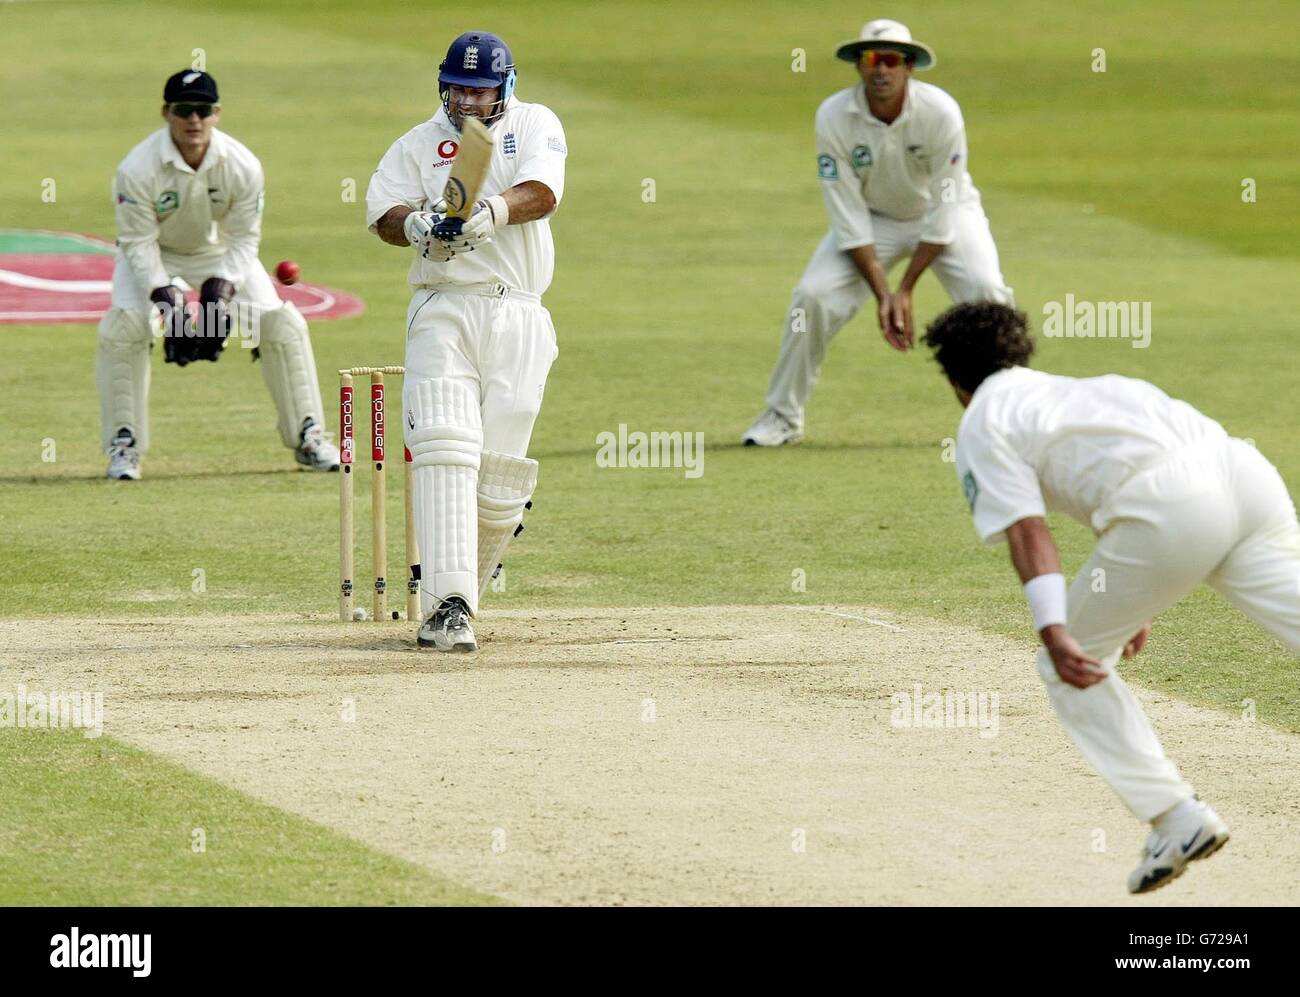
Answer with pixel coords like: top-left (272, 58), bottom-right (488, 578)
top-left (365, 97), bottom-right (568, 295)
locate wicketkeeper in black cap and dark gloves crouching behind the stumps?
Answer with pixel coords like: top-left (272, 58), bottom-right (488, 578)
top-left (96, 70), bottom-right (338, 480)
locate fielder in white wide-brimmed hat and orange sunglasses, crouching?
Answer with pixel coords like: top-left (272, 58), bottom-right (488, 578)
top-left (744, 19), bottom-right (1013, 446)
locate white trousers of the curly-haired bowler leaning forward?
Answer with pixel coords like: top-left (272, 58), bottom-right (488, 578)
top-left (1039, 439), bottom-right (1300, 820)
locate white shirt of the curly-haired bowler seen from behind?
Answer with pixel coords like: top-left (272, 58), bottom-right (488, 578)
top-left (957, 367), bottom-right (1227, 545)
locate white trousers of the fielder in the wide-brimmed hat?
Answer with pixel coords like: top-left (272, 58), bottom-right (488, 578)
top-left (767, 201), bottom-right (1014, 429)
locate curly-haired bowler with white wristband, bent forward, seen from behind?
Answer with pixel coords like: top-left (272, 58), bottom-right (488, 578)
top-left (926, 304), bottom-right (1300, 893)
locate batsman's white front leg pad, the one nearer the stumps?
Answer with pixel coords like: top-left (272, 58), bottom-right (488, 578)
top-left (406, 378), bottom-right (484, 616)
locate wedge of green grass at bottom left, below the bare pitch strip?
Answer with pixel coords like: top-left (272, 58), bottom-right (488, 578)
top-left (0, 729), bottom-right (494, 906)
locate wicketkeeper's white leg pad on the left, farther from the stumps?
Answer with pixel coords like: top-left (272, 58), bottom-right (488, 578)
top-left (95, 308), bottom-right (152, 454)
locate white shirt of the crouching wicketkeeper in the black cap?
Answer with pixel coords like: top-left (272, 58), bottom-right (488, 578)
top-left (113, 127), bottom-right (265, 292)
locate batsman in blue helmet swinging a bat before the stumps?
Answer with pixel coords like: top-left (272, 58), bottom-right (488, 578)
top-left (365, 31), bottom-right (567, 651)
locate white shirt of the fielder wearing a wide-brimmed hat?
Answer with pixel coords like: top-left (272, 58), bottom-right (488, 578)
top-left (816, 79), bottom-right (979, 250)
